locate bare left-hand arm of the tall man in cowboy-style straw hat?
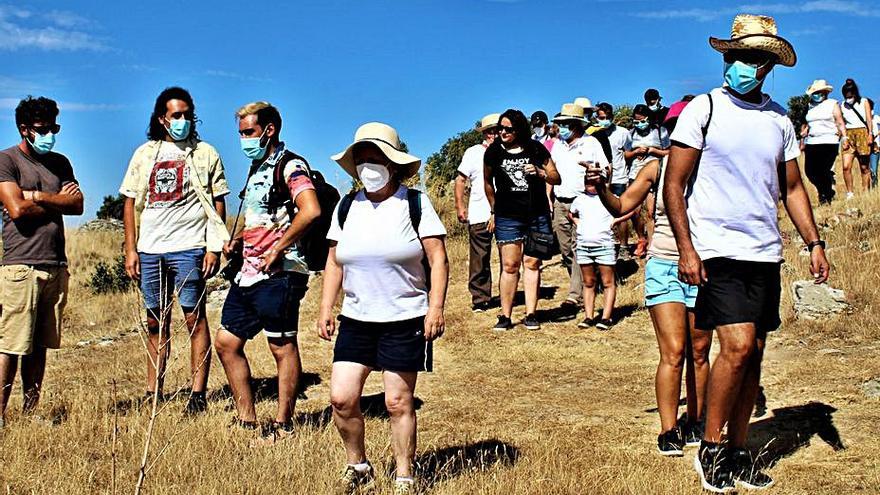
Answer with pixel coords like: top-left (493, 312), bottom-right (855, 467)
top-left (663, 142), bottom-right (708, 285)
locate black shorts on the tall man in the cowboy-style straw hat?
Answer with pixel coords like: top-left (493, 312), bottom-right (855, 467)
top-left (694, 258), bottom-right (782, 334)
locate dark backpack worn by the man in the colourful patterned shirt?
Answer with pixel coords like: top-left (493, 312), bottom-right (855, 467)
top-left (269, 150), bottom-right (339, 272)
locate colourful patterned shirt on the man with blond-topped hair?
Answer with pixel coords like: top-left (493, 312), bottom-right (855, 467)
top-left (236, 143), bottom-right (315, 287)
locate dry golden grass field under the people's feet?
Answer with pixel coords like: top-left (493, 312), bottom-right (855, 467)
top-left (0, 164), bottom-right (880, 495)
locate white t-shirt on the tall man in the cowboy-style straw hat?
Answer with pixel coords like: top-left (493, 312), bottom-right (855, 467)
top-left (672, 88), bottom-right (800, 262)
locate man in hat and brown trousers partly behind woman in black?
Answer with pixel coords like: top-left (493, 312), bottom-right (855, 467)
top-left (455, 113), bottom-right (501, 312)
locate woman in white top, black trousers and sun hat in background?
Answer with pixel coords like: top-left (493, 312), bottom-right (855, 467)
top-left (801, 79), bottom-right (846, 204)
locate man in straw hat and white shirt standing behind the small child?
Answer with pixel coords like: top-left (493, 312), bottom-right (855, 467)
top-left (551, 100), bottom-right (608, 318)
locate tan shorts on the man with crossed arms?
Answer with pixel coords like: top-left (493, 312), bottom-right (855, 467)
top-left (0, 265), bottom-right (70, 356)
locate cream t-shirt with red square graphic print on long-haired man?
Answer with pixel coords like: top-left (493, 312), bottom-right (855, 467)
top-left (137, 141), bottom-right (208, 254)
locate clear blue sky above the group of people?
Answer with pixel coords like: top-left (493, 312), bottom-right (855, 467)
top-left (0, 0), bottom-right (880, 218)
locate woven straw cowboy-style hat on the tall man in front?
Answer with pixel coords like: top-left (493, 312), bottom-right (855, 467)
top-left (709, 14), bottom-right (797, 67)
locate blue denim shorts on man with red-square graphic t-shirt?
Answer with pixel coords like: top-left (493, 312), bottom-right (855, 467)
top-left (138, 248), bottom-right (205, 313)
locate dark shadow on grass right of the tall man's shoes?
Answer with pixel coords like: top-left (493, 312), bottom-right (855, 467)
top-left (748, 402), bottom-right (845, 469)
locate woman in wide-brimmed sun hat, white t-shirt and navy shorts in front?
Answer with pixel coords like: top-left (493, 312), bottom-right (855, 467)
top-left (317, 122), bottom-right (449, 494)
